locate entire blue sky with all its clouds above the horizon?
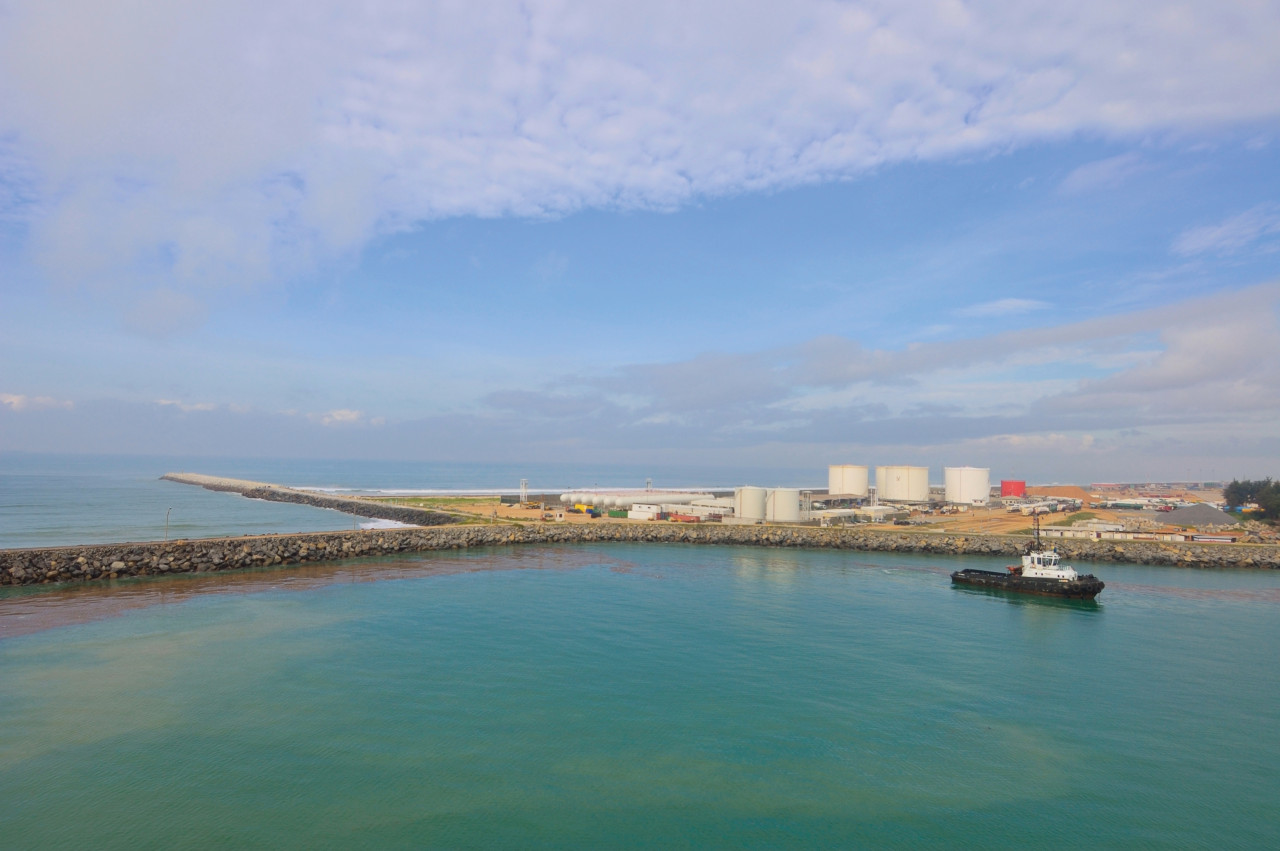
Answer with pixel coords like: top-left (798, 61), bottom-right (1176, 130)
top-left (0, 0), bottom-right (1280, 482)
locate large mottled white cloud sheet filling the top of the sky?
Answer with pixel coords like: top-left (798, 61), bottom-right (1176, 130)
top-left (0, 0), bottom-right (1280, 305)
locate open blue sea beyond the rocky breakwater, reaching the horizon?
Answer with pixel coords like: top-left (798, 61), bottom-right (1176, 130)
top-left (0, 453), bottom-right (826, 549)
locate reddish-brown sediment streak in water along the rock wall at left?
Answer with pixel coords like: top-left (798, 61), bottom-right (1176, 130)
top-left (0, 546), bottom-right (631, 640)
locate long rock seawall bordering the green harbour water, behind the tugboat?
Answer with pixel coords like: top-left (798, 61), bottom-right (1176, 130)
top-left (0, 522), bottom-right (1280, 585)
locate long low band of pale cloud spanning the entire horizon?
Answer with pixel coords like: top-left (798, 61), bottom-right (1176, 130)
top-left (0, 277), bottom-right (1280, 470)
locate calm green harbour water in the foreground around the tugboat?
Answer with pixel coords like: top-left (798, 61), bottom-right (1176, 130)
top-left (0, 545), bottom-right (1280, 848)
